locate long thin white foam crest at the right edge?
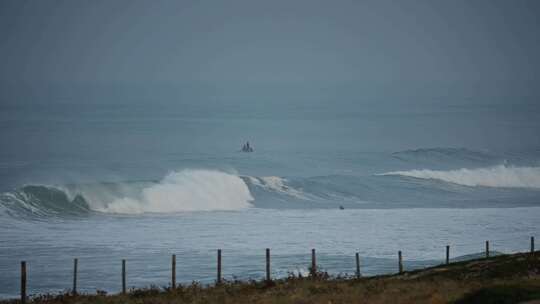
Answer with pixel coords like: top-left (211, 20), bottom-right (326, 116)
top-left (380, 165), bottom-right (540, 188)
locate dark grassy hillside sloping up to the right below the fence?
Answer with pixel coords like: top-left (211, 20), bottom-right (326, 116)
top-left (4, 253), bottom-right (540, 304)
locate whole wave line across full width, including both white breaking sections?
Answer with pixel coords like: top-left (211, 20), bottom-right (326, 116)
top-left (4, 159), bottom-right (540, 219)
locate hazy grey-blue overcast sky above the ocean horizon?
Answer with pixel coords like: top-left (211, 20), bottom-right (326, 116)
top-left (0, 0), bottom-right (540, 103)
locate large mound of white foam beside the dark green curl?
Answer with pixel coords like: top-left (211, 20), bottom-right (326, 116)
top-left (99, 170), bottom-right (253, 214)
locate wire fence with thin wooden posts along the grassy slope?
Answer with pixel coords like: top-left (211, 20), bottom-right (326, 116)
top-left (6, 237), bottom-right (535, 303)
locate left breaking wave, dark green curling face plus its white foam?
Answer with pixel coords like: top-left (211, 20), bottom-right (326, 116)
top-left (0, 170), bottom-right (254, 216)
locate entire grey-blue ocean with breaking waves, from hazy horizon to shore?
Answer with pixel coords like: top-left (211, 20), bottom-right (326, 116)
top-left (0, 99), bottom-right (540, 298)
